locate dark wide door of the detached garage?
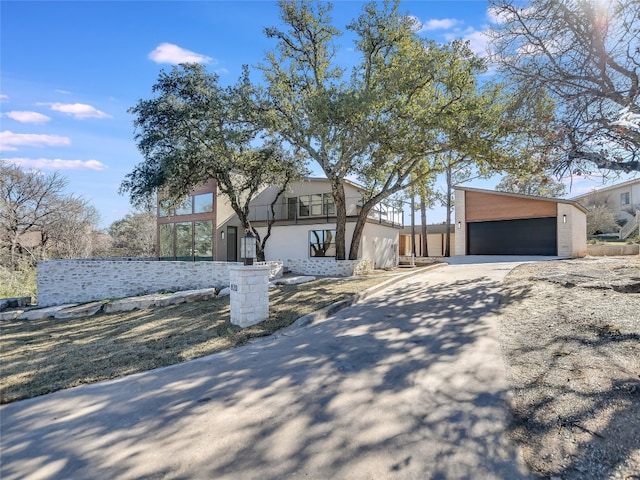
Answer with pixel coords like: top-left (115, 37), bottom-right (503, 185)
top-left (467, 218), bottom-right (558, 256)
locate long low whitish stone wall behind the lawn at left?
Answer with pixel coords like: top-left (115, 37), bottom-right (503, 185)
top-left (37, 259), bottom-right (283, 307)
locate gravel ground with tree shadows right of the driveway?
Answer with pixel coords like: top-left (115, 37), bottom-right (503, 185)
top-left (500, 256), bottom-right (640, 480)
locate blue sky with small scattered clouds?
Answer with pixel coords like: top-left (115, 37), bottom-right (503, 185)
top-left (0, 0), bottom-right (632, 227)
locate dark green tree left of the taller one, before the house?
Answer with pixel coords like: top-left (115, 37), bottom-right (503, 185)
top-left (121, 64), bottom-right (304, 259)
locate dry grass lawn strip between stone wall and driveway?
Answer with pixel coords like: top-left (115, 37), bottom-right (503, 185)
top-left (0, 272), bottom-right (402, 403)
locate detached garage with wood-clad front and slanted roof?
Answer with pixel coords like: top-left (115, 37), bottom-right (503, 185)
top-left (455, 187), bottom-right (587, 257)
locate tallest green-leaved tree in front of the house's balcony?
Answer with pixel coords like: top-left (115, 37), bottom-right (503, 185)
top-left (261, 0), bottom-right (526, 259)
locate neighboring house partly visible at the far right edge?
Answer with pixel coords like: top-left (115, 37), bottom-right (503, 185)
top-left (571, 178), bottom-right (640, 238)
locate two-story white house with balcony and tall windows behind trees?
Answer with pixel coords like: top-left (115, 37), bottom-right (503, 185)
top-left (158, 178), bottom-right (403, 268)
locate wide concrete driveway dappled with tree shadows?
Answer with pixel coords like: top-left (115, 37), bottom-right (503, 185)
top-left (0, 261), bottom-right (544, 480)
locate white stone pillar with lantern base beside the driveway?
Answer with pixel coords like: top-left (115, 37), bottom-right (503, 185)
top-left (229, 265), bottom-right (269, 328)
